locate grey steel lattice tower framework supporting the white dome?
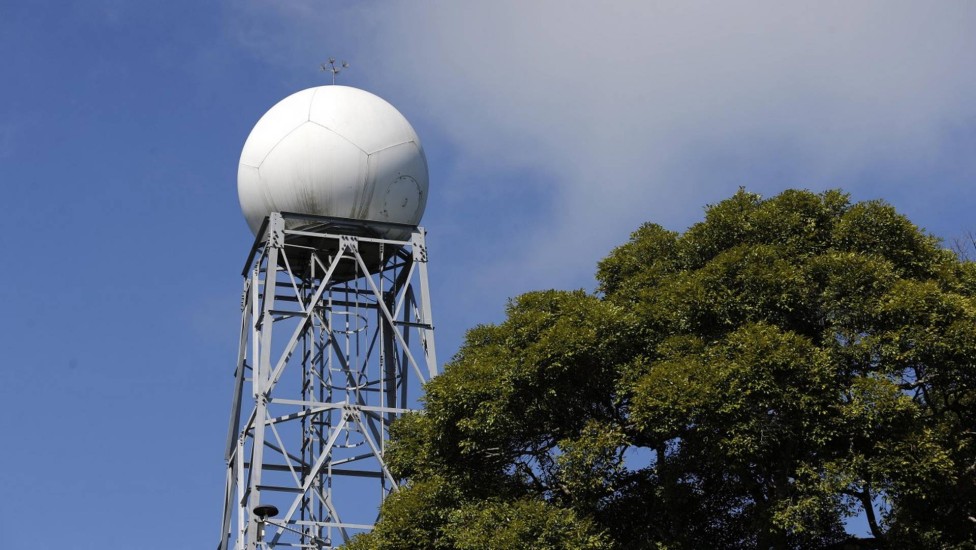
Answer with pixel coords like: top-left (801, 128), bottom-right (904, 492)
top-left (218, 213), bottom-right (437, 550)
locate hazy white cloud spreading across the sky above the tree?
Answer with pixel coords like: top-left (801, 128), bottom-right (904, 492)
top-left (227, 0), bottom-right (976, 294)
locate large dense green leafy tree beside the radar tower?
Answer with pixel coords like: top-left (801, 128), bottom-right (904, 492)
top-left (351, 191), bottom-right (976, 549)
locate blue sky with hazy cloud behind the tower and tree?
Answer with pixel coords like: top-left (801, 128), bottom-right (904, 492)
top-left (0, 0), bottom-right (976, 549)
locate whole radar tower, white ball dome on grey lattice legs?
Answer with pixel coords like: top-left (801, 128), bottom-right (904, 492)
top-left (218, 71), bottom-right (437, 550)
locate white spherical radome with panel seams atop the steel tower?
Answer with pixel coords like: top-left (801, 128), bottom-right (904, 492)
top-left (237, 86), bottom-right (428, 238)
